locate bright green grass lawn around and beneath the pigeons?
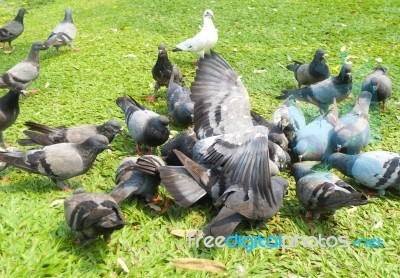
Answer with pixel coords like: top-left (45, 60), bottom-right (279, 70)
top-left (0, 0), bottom-right (400, 277)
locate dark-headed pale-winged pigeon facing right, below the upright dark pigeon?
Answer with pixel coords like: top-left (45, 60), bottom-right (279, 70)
top-left (116, 95), bottom-right (170, 154)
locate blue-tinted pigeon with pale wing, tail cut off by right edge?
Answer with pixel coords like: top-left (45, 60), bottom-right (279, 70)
top-left (328, 151), bottom-right (400, 196)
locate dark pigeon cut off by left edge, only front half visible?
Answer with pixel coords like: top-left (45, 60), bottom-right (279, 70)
top-left (0, 88), bottom-right (23, 148)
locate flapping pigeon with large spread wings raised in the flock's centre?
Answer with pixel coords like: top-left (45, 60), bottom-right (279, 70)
top-left (159, 51), bottom-right (283, 236)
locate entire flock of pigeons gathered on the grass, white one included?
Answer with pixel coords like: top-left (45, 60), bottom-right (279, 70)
top-left (0, 8), bottom-right (400, 245)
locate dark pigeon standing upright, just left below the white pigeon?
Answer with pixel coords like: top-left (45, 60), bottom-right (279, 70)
top-left (146, 44), bottom-right (183, 102)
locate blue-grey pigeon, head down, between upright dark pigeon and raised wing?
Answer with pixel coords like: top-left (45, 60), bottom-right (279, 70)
top-left (167, 68), bottom-right (194, 125)
